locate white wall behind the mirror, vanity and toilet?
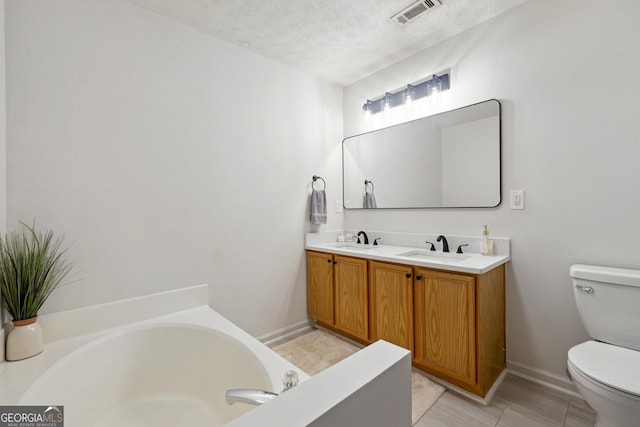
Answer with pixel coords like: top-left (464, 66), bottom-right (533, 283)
top-left (344, 0), bottom-right (640, 381)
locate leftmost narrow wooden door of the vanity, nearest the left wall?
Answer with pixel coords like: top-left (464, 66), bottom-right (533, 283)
top-left (307, 251), bottom-right (334, 325)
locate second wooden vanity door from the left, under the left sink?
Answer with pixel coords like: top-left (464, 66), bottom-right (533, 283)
top-left (333, 255), bottom-right (369, 340)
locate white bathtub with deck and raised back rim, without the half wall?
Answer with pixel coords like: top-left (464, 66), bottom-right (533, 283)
top-left (0, 285), bottom-right (309, 427)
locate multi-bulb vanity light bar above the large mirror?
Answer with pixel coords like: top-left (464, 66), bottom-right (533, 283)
top-left (362, 73), bottom-right (450, 117)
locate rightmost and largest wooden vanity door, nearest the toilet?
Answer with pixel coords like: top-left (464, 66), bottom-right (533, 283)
top-left (414, 269), bottom-right (477, 385)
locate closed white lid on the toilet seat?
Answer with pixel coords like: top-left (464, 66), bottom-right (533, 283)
top-left (568, 341), bottom-right (640, 396)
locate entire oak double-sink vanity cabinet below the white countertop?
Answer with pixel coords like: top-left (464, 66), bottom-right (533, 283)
top-left (307, 251), bottom-right (506, 396)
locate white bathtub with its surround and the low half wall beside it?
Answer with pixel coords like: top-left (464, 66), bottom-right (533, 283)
top-left (0, 285), bottom-right (411, 427)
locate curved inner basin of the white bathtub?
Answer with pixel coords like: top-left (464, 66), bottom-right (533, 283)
top-left (19, 324), bottom-right (280, 427)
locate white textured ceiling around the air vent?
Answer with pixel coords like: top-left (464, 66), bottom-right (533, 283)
top-left (129, 0), bottom-right (526, 85)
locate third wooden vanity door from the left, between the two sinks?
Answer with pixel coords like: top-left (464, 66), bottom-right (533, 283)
top-left (369, 261), bottom-right (413, 351)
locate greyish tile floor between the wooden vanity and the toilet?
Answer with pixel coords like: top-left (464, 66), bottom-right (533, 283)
top-left (415, 375), bottom-right (596, 427)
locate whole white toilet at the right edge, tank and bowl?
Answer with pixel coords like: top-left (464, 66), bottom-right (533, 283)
top-left (567, 264), bottom-right (640, 427)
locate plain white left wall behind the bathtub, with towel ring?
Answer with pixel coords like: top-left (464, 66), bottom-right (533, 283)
top-left (6, 0), bottom-right (342, 342)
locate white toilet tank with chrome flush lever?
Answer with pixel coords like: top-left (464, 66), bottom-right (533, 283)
top-left (569, 264), bottom-right (640, 351)
